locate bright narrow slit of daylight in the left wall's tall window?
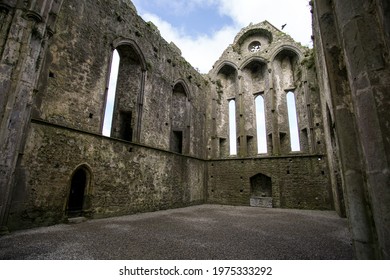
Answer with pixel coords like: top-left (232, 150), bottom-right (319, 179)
top-left (103, 50), bottom-right (120, 136)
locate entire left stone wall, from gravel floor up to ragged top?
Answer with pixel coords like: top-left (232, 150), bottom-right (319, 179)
top-left (3, 0), bottom-right (208, 229)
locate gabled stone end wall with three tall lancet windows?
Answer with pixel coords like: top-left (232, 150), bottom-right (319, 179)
top-left (207, 22), bottom-right (333, 209)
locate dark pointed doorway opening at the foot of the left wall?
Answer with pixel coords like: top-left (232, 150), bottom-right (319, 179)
top-left (67, 168), bottom-right (87, 217)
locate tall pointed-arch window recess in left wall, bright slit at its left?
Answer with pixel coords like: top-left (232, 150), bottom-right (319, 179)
top-left (102, 41), bottom-right (146, 142)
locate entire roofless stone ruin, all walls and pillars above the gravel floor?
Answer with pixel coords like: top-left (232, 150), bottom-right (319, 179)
top-left (0, 0), bottom-right (390, 259)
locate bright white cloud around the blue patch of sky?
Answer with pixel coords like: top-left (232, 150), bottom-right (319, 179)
top-left (136, 0), bottom-right (311, 73)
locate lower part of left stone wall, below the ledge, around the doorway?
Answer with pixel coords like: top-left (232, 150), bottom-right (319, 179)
top-left (8, 121), bottom-right (205, 230)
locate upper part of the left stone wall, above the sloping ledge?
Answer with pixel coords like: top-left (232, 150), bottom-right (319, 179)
top-left (34, 0), bottom-right (208, 157)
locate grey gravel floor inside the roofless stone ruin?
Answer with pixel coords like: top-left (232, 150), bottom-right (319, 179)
top-left (0, 205), bottom-right (353, 260)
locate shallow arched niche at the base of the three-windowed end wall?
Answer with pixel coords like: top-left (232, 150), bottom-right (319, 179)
top-left (250, 173), bottom-right (272, 208)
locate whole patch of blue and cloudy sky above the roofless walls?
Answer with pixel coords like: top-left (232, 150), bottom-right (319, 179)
top-left (133, 0), bottom-right (311, 73)
